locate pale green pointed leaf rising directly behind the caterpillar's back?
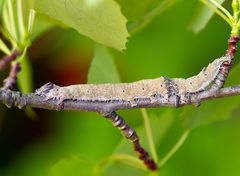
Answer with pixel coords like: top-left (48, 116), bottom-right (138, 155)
top-left (88, 44), bottom-right (120, 84)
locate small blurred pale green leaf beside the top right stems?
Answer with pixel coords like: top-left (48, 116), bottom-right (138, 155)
top-left (188, 0), bottom-right (225, 33)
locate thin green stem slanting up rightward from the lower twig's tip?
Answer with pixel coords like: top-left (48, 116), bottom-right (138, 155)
top-left (158, 129), bottom-right (190, 167)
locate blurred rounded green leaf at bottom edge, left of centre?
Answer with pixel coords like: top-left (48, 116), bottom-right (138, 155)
top-left (50, 156), bottom-right (91, 176)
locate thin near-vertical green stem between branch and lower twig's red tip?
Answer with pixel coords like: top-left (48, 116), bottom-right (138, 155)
top-left (141, 109), bottom-right (158, 162)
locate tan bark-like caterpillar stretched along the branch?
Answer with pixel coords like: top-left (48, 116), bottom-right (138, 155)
top-left (36, 56), bottom-right (231, 112)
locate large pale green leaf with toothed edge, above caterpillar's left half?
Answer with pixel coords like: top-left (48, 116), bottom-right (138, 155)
top-left (34, 0), bottom-right (129, 50)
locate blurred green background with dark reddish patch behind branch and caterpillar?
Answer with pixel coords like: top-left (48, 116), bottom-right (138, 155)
top-left (0, 0), bottom-right (240, 176)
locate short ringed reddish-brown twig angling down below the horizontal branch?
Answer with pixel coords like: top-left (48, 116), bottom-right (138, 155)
top-left (104, 111), bottom-right (157, 171)
